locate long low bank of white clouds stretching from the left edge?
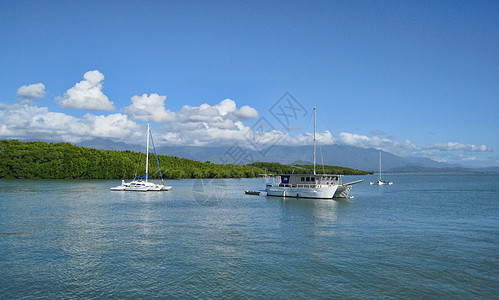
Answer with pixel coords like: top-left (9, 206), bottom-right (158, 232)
top-left (0, 96), bottom-right (264, 145)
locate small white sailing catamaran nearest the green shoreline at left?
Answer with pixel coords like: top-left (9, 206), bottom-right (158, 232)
top-left (111, 123), bottom-right (172, 192)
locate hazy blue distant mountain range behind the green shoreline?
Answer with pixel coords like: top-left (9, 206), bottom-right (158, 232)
top-left (76, 138), bottom-right (499, 172)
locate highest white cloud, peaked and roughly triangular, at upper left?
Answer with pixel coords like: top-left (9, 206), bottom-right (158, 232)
top-left (57, 70), bottom-right (114, 111)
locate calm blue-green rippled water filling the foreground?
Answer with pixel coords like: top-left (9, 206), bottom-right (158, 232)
top-left (0, 174), bottom-right (499, 299)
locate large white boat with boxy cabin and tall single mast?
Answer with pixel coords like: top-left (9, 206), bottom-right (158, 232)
top-left (263, 107), bottom-right (364, 199)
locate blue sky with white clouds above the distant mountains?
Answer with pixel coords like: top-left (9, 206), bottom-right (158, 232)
top-left (0, 0), bottom-right (499, 166)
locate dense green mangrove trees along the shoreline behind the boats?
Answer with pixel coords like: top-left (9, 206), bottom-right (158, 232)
top-left (0, 140), bottom-right (372, 179)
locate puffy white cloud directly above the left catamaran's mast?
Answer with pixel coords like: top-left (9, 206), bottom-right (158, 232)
top-left (125, 94), bottom-right (175, 123)
